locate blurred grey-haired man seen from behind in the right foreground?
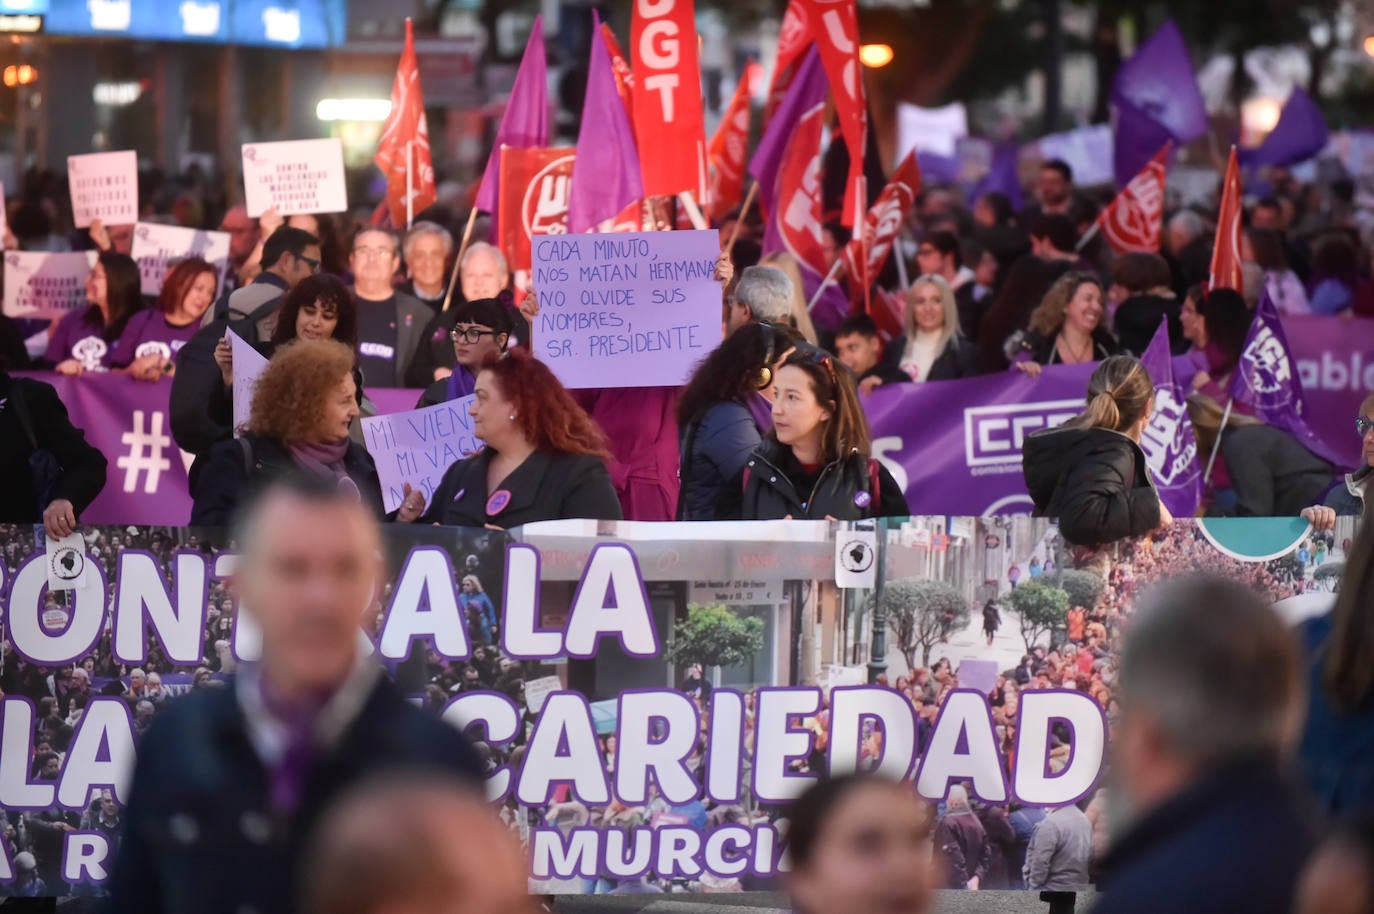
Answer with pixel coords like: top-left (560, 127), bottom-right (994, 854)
top-left (1094, 577), bottom-right (1312, 914)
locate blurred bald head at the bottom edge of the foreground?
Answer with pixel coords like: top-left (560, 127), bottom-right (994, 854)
top-left (301, 778), bottom-right (539, 914)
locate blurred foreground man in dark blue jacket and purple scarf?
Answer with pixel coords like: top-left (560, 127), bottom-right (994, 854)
top-left (109, 477), bottom-right (484, 914)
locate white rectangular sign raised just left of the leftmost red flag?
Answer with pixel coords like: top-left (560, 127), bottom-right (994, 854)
top-left (243, 137), bottom-right (348, 219)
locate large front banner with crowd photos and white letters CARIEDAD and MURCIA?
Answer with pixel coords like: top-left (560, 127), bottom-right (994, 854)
top-left (0, 517), bottom-right (1355, 895)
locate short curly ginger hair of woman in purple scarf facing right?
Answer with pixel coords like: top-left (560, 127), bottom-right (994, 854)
top-left (245, 339), bottom-right (353, 444)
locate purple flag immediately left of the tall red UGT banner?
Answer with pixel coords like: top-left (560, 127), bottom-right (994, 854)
top-left (567, 10), bottom-right (644, 232)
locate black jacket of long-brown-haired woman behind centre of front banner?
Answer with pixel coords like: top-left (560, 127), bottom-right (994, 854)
top-left (716, 437), bottom-right (911, 521)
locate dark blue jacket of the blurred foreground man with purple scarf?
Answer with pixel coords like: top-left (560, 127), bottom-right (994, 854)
top-left (106, 678), bottom-right (484, 914)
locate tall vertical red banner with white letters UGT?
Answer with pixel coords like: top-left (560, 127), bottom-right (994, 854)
top-left (629, 0), bottom-right (706, 203)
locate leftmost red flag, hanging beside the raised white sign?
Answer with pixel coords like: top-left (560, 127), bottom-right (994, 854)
top-left (374, 19), bottom-right (438, 228)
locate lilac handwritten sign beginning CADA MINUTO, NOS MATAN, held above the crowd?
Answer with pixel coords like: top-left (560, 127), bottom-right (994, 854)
top-left (533, 230), bottom-right (720, 389)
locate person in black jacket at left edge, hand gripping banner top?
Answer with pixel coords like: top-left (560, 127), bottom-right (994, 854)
top-left (0, 368), bottom-right (107, 539)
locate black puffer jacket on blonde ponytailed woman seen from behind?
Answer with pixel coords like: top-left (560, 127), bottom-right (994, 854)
top-left (1021, 427), bottom-right (1161, 546)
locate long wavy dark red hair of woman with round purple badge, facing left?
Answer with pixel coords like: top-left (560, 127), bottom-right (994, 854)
top-left (478, 349), bottom-right (610, 460)
